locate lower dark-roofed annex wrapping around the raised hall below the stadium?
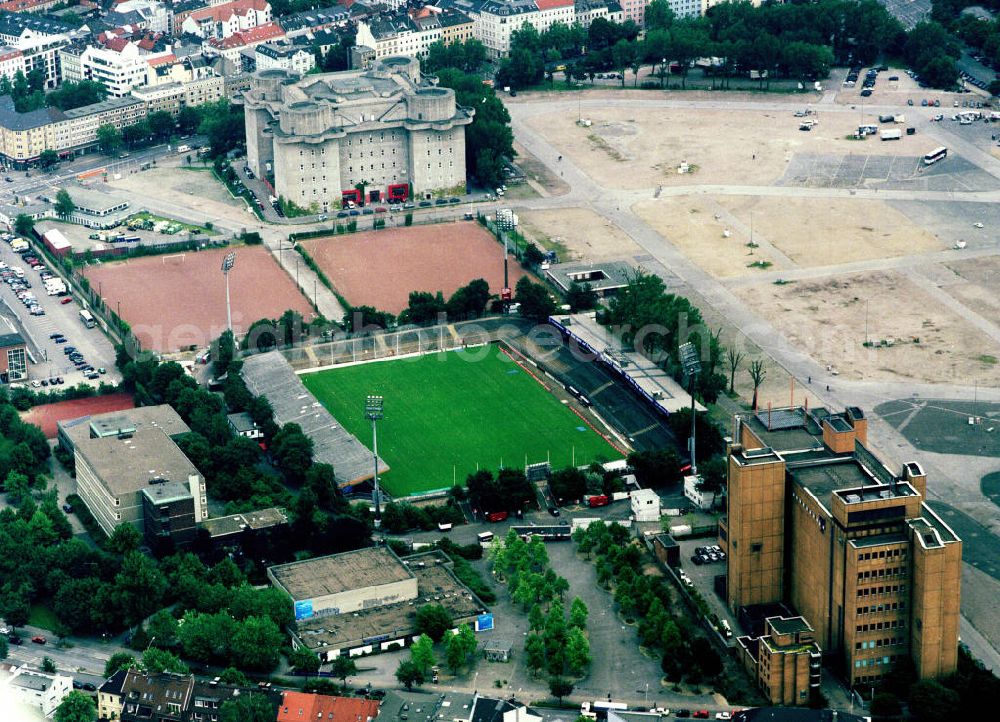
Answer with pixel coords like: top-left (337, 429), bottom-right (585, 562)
top-left (292, 552), bottom-right (493, 661)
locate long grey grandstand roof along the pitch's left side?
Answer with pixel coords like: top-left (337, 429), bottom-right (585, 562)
top-left (243, 351), bottom-right (389, 487)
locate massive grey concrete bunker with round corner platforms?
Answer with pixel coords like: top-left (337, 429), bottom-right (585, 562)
top-left (244, 58), bottom-right (475, 210)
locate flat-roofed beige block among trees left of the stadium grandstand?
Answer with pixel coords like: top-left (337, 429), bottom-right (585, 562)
top-left (74, 428), bottom-right (208, 542)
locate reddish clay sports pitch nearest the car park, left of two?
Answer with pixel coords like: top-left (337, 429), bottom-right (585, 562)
top-left (84, 247), bottom-right (314, 351)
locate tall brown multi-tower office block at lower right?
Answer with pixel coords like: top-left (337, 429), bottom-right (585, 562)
top-left (719, 407), bottom-right (962, 686)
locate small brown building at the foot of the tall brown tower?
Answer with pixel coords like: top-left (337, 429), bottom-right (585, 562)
top-left (736, 617), bottom-right (823, 705)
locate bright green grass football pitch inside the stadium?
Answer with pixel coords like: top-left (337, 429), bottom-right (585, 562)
top-left (302, 346), bottom-right (621, 497)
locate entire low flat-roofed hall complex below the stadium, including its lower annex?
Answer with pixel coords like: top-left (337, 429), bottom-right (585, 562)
top-left (267, 547), bottom-right (493, 661)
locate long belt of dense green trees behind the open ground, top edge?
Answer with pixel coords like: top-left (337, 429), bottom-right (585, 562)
top-left (492, 0), bottom-right (957, 88)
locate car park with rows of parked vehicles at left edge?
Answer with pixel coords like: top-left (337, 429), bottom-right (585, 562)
top-left (0, 233), bottom-right (119, 387)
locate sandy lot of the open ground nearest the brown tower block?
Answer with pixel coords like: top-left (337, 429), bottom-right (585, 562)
top-left (736, 272), bottom-right (1000, 386)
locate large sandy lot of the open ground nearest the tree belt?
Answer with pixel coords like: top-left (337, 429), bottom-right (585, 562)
top-left (527, 106), bottom-right (941, 189)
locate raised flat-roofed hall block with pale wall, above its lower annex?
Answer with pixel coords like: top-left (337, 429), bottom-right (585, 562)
top-left (267, 547), bottom-right (417, 619)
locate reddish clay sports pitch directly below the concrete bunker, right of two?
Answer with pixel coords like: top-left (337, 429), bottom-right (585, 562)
top-left (301, 221), bottom-right (524, 314)
